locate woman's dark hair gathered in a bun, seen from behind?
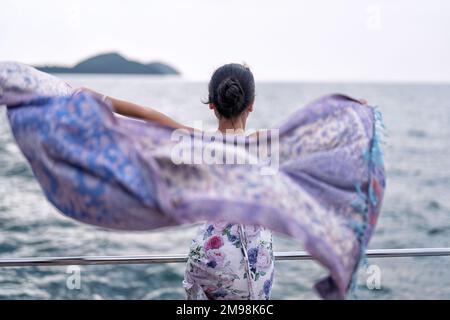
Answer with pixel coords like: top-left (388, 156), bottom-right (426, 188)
top-left (206, 63), bottom-right (255, 119)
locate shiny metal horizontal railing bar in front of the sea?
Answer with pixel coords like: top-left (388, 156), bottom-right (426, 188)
top-left (0, 248), bottom-right (450, 267)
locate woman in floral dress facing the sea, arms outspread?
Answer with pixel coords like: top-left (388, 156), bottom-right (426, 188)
top-left (83, 64), bottom-right (274, 300)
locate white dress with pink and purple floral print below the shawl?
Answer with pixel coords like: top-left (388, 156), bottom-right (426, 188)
top-left (183, 222), bottom-right (274, 300)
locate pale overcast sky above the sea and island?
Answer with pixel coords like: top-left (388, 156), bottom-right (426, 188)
top-left (0, 0), bottom-right (450, 82)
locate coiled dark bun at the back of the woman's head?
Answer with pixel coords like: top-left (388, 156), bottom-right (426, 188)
top-left (216, 78), bottom-right (246, 118)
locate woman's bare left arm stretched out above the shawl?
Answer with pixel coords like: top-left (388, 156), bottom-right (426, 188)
top-left (77, 88), bottom-right (192, 130)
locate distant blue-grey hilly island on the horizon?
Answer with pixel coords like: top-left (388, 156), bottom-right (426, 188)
top-left (36, 53), bottom-right (179, 75)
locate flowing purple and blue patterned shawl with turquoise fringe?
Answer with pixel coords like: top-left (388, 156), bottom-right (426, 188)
top-left (0, 62), bottom-right (385, 299)
